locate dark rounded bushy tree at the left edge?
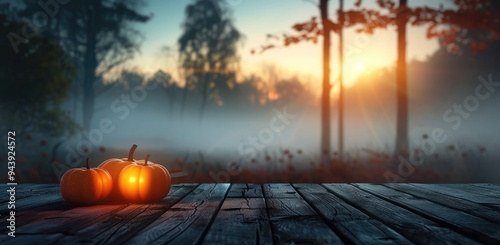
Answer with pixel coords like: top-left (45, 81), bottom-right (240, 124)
top-left (0, 15), bottom-right (78, 138)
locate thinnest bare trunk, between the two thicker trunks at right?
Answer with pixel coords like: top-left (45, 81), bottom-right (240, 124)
top-left (338, 0), bottom-right (344, 162)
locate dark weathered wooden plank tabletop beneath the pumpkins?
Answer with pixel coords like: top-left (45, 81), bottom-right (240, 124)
top-left (0, 184), bottom-right (500, 244)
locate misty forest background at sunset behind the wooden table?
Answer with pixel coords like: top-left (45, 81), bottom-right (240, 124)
top-left (0, 0), bottom-right (500, 183)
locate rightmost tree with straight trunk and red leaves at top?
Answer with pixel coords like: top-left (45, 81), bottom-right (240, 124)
top-left (347, 0), bottom-right (500, 157)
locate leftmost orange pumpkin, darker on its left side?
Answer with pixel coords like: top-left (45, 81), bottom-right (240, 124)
top-left (61, 158), bottom-right (113, 205)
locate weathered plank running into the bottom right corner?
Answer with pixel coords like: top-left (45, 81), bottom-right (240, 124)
top-left (356, 184), bottom-right (500, 244)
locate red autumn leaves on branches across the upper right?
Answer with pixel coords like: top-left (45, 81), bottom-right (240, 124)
top-left (252, 0), bottom-right (500, 54)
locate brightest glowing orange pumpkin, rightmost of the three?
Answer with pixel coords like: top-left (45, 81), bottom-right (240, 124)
top-left (118, 154), bottom-right (172, 203)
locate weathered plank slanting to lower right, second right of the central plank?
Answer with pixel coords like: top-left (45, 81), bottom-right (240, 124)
top-left (293, 184), bottom-right (412, 244)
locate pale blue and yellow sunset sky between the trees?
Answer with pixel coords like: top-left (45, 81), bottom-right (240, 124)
top-left (127, 0), bottom-right (458, 91)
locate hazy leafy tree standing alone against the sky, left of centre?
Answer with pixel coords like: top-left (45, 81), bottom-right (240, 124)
top-left (178, 0), bottom-right (242, 121)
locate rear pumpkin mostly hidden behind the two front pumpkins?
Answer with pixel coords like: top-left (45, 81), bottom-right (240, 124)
top-left (99, 144), bottom-right (137, 200)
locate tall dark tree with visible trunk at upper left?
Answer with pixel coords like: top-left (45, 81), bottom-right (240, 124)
top-left (21, 0), bottom-right (150, 130)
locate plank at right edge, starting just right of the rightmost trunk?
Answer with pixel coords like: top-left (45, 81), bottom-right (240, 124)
top-left (412, 184), bottom-right (500, 210)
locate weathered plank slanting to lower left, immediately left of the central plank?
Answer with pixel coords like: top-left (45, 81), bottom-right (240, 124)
top-left (130, 184), bottom-right (230, 244)
